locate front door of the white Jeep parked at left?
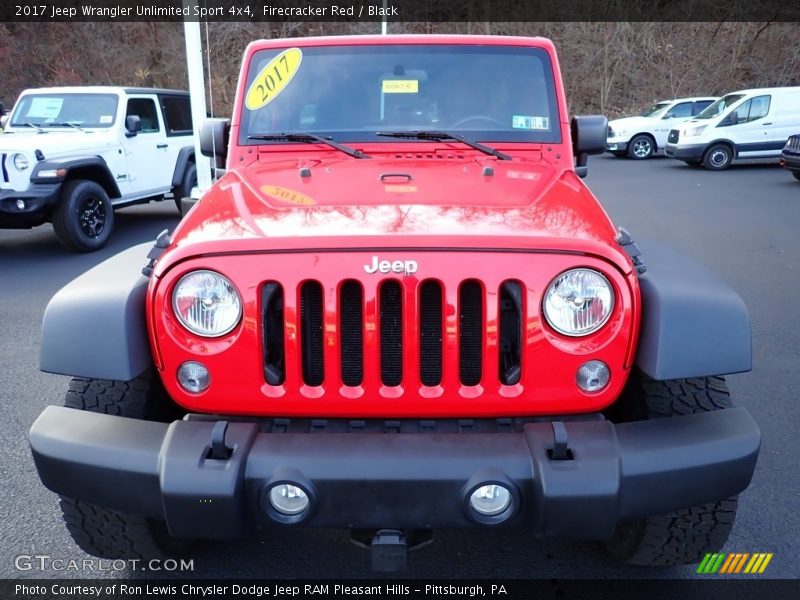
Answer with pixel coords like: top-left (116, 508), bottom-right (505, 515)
top-left (123, 95), bottom-right (175, 198)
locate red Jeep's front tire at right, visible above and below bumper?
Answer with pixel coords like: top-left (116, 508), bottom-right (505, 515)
top-left (605, 373), bottom-right (737, 566)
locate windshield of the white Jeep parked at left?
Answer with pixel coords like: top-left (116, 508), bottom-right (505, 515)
top-left (11, 94), bottom-right (117, 128)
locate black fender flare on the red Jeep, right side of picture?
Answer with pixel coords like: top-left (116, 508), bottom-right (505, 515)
top-left (636, 239), bottom-right (752, 380)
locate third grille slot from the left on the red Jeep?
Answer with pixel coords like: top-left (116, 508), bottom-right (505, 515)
top-left (339, 280), bottom-right (364, 385)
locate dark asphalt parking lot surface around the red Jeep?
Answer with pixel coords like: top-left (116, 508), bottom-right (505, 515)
top-left (0, 155), bottom-right (800, 579)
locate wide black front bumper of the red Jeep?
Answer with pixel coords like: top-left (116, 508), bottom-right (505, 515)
top-left (30, 406), bottom-right (761, 539)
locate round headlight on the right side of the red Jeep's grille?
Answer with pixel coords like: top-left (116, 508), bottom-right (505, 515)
top-left (543, 269), bottom-right (614, 336)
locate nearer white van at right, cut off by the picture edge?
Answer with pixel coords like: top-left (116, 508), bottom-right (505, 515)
top-left (664, 87), bottom-right (800, 171)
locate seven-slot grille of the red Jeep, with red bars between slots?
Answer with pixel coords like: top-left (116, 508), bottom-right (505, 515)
top-left (261, 278), bottom-right (526, 390)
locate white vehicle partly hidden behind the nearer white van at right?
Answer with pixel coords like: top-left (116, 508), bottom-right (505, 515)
top-left (606, 96), bottom-right (717, 160)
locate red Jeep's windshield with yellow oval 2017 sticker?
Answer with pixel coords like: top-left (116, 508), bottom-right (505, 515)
top-left (240, 45), bottom-right (560, 144)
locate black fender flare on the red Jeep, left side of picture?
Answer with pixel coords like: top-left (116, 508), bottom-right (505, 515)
top-left (39, 242), bottom-right (153, 381)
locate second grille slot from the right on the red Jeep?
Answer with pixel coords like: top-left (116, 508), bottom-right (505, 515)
top-left (458, 279), bottom-right (483, 385)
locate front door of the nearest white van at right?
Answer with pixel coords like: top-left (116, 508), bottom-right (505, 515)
top-left (717, 94), bottom-right (775, 158)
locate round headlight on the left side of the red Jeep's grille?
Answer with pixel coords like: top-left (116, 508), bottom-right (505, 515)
top-left (172, 271), bottom-right (242, 337)
